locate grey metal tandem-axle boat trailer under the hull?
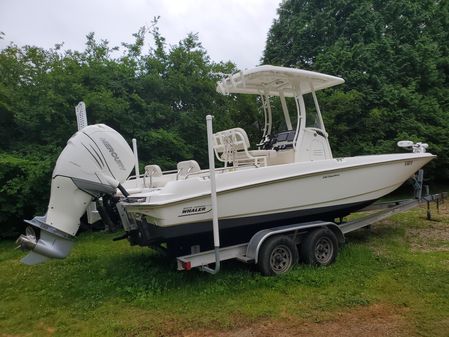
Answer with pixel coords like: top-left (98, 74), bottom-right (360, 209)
top-left (177, 192), bottom-right (448, 275)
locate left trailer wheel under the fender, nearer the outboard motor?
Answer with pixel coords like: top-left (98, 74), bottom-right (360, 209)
top-left (258, 235), bottom-right (298, 276)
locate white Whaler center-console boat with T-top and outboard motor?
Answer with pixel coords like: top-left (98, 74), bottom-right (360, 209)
top-left (19, 65), bottom-right (435, 264)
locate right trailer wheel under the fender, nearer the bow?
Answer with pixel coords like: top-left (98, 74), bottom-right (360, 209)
top-left (301, 228), bottom-right (338, 266)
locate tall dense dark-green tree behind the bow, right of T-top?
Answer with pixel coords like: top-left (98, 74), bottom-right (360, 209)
top-left (263, 0), bottom-right (449, 180)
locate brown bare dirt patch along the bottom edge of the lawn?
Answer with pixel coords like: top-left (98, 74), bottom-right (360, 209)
top-left (182, 304), bottom-right (413, 337)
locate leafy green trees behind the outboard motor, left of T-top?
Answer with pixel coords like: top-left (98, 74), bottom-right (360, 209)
top-left (0, 23), bottom-right (257, 233)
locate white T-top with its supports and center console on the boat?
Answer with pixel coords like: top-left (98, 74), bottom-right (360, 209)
top-left (217, 65), bottom-right (344, 165)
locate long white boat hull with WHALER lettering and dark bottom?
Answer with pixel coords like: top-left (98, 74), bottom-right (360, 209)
top-left (123, 153), bottom-right (434, 240)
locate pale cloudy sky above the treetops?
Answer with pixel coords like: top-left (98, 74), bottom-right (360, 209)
top-left (0, 0), bottom-right (281, 69)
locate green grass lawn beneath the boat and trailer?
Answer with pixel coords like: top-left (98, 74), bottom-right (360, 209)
top-left (0, 203), bottom-right (449, 337)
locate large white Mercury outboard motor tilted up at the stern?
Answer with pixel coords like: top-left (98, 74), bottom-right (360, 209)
top-left (17, 124), bottom-right (134, 265)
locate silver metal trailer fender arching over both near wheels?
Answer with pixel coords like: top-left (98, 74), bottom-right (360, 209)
top-left (246, 221), bottom-right (344, 263)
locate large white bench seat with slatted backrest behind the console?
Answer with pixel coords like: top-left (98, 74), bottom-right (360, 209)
top-left (213, 128), bottom-right (276, 167)
